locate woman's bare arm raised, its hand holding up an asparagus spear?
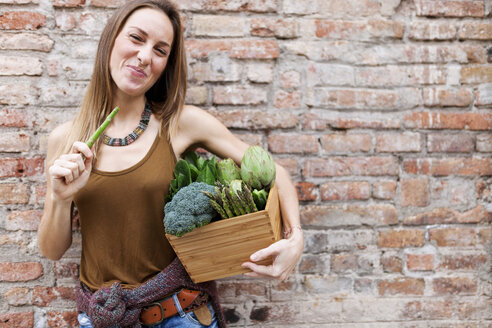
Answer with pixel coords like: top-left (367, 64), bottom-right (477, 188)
top-left (38, 124), bottom-right (92, 260)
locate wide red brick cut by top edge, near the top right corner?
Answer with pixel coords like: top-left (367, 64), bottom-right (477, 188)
top-left (415, 0), bottom-right (485, 17)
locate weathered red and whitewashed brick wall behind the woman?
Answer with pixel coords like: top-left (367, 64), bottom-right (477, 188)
top-left (0, 0), bottom-right (492, 328)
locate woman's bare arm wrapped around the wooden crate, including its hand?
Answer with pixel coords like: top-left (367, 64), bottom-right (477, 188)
top-left (172, 106), bottom-right (304, 280)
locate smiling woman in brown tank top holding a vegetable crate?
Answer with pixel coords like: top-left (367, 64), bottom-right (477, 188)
top-left (38, 0), bottom-right (303, 327)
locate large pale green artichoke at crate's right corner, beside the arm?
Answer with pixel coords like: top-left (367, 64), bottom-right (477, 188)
top-left (241, 146), bottom-right (276, 190)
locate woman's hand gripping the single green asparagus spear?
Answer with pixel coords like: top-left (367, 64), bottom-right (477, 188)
top-left (49, 141), bottom-right (93, 202)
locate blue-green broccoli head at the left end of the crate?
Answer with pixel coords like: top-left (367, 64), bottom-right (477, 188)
top-left (164, 182), bottom-right (217, 237)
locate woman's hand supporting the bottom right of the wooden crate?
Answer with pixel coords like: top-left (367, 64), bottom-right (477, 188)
top-left (242, 229), bottom-right (304, 281)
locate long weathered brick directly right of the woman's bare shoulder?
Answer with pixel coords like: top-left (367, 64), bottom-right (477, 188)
top-left (210, 110), bottom-right (298, 129)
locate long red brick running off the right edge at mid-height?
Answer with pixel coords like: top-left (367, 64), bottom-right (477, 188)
top-left (403, 157), bottom-right (492, 176)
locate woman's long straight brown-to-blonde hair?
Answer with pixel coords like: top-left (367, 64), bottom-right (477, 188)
top-left (54, 0), bottom-right (187, 163)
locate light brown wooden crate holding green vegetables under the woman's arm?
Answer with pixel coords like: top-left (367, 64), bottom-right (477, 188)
top-left (166, 185), bottom-right (282, 283)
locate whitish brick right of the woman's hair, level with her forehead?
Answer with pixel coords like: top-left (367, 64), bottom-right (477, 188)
top-left (192, 15), bottom-right (245, 37)
